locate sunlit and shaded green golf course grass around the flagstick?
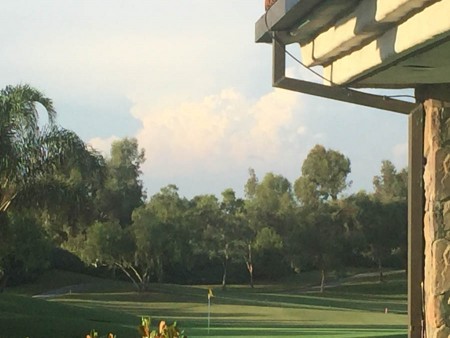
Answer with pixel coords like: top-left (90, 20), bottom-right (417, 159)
top-left (0, 272), bottom-right (407, 338)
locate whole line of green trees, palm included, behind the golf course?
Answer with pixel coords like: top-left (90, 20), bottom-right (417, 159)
top-left (0, 85), bottom-right (407, 290)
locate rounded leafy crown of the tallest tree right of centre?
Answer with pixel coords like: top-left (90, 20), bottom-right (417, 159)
top-left (294, 145), bottom-right (351, 204)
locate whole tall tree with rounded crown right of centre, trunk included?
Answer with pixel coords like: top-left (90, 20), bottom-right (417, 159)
top-left (294, 145), bottom-right (350, 291)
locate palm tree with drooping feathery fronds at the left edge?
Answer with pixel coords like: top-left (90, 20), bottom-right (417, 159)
top-left (0, 85), bottom-right (103, 213)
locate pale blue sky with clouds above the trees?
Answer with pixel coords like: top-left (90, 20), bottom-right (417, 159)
top-left (0, 0), bottom-right (408, 198)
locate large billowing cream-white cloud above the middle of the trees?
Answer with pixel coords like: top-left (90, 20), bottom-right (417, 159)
top-left (126, 88), bottom-right (305, 177)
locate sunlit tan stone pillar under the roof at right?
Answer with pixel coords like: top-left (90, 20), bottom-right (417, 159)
top-left (416, 85), bottom-right (450, 338)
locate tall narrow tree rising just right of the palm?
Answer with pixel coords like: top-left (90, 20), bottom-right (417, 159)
top-left (98, 138), bottom-right (145, 227)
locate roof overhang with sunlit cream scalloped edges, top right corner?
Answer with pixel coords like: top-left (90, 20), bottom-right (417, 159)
top-left (255, 0), bottom-right (450, 88)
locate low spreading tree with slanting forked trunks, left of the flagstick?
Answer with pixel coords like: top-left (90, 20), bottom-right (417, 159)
top-left (80, 186), bottom-right (182, 291)
